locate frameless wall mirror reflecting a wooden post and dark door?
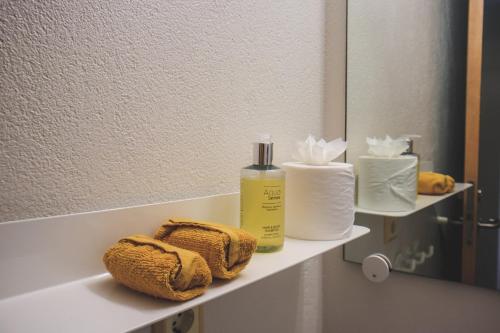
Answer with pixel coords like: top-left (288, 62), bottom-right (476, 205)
top-left (344, 0), bottom-right (500, 289)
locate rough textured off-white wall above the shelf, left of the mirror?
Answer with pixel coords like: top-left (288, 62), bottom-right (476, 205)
top-left (0, 0), bottom-right (325, 221)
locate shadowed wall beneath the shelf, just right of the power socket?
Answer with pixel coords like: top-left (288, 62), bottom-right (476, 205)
top-left (203, 257), bottom-right (327, 333)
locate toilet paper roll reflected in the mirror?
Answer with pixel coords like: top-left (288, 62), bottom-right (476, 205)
top-left (358, 155), bottom-right (418, 212)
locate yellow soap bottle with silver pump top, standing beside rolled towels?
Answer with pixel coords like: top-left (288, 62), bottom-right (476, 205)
top-left (240, 135), bottom-right (285, 252)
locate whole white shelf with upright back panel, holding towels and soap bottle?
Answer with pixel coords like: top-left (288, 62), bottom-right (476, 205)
top-left (0, 193), bottom-right (369, 333)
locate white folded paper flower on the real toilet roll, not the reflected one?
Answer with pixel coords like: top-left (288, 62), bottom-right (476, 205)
top-left (292, 135), bottom-right (347, 165)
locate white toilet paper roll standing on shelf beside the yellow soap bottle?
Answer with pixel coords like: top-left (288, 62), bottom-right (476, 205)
top-left (283, 162), bottom-right (354, 240)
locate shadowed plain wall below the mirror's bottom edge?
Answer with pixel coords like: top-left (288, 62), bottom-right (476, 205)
top-left (323, 251), bottom-right (500, 333)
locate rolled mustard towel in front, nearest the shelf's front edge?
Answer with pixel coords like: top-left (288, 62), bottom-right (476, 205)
top-left (103, 235), bottom-right (212, 301)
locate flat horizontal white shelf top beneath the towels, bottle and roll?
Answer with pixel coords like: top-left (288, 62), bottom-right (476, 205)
top-left (0, 226), bottom-right (369, 332)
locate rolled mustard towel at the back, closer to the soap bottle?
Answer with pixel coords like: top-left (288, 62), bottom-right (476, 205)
top-left (155, 218), bottom-right (257, 279)
